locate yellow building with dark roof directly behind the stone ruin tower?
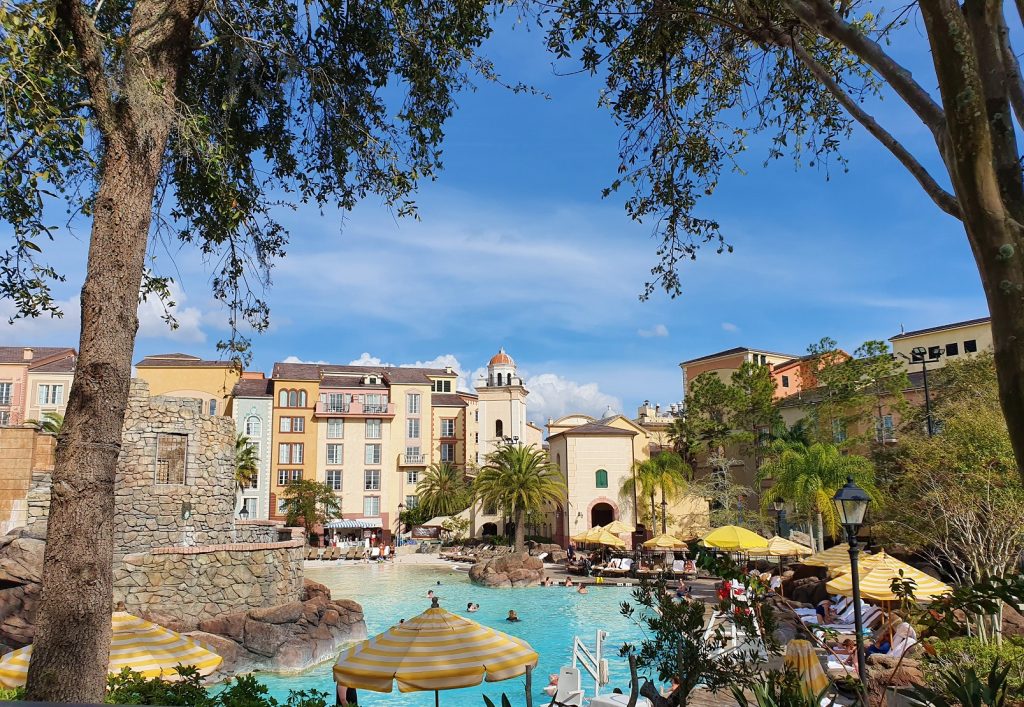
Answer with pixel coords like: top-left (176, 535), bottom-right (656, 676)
top-left (135, 354), bottom-right (242, 415)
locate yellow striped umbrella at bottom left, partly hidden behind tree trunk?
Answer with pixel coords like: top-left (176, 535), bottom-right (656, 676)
top-left (0, 612), bottom-right (224, 689)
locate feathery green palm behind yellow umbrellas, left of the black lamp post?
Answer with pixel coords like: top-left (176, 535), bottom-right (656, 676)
top-left (758, 441), bottom-right (878, 550)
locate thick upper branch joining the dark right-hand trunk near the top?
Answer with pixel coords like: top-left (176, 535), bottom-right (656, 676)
top-left (785, 0), bottom-right (949, 155)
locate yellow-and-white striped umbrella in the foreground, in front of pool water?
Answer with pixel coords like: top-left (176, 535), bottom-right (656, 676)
top-left (334, 598), bottom-right (538, 702)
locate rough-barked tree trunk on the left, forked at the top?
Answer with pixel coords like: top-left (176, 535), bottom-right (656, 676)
top-left (26, 0), bottom-right (202, 703)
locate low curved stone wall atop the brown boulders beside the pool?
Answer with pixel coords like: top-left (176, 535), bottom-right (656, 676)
top-left (114, 539), bottom-right (305, 630)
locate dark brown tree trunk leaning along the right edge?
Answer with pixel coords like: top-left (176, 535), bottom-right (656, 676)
top-left (920, 0), bottom-right (1024, 480)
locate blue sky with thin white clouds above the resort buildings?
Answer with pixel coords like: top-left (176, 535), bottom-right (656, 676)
top-left (0, 16), bottom-right (987, 421)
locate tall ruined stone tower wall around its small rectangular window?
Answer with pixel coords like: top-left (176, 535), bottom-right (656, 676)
top-left (114, 378), bottom-right (237, 553)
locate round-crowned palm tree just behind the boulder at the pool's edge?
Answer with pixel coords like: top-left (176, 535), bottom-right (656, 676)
top-left (474, 444), bottom-right (566, 550)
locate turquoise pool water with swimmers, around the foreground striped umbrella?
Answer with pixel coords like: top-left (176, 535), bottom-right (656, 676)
top-left (253, 565), bottom-right (655, 707)
